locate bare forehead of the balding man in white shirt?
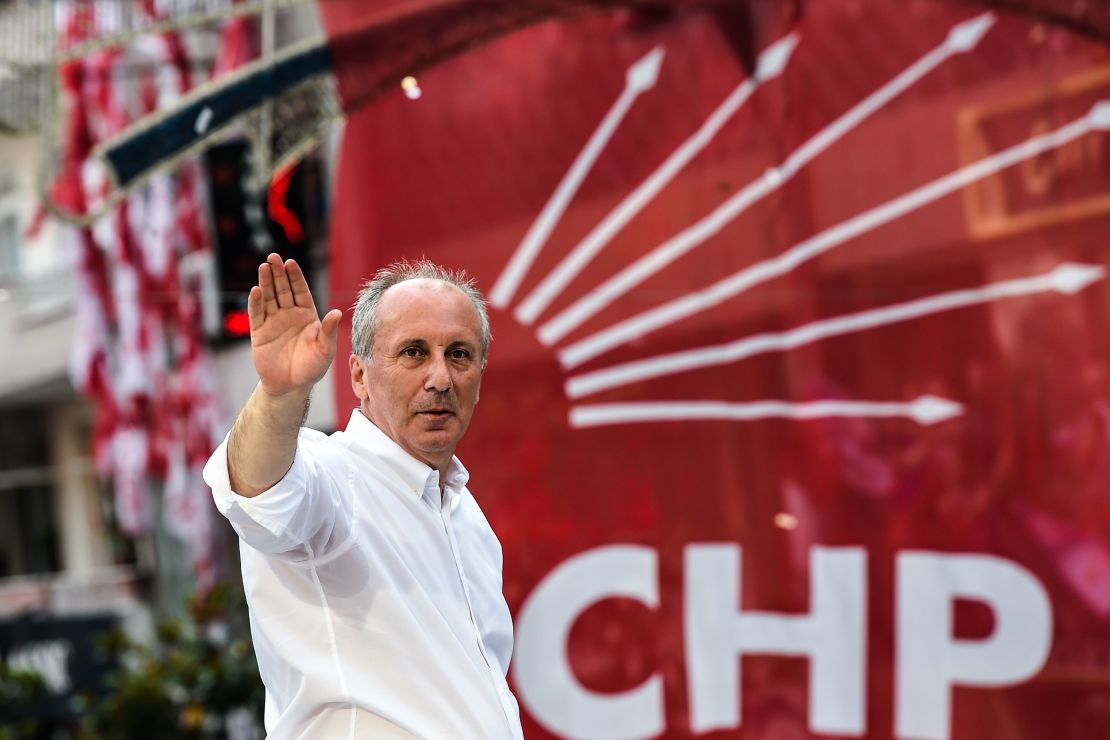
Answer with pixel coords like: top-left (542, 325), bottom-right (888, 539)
top-left (377, 277), bottom-right (482, 342)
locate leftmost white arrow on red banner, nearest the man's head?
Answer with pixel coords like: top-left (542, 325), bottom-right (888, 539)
top-left (490, 47), bottom-right (663, 308)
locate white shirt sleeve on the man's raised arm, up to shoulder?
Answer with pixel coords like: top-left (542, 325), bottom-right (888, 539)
top-left (204, 428), bottom-right (352, 560)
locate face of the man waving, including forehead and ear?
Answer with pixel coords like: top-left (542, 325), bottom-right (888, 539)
top-left (351, 278), bottom-right (483, 472)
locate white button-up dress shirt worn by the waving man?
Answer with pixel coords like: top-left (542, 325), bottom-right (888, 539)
top-left (204, 409), bottom-right (523, 740)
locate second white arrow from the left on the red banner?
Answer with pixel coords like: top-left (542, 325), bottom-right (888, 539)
top-left (514, 33), bottom-right (798, 325)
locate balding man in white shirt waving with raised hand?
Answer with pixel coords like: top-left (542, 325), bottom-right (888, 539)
top-left (204, 254), bottom-right (522, 740)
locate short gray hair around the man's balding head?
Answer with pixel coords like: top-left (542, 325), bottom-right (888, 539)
top-left (351, 260), bottom-right (490, 363)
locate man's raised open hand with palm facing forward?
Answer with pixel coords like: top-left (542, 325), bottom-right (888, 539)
top-left (246, 254), bottom-right (343, 396)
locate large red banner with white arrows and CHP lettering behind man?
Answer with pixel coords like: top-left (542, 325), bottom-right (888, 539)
top-left (321, 0), bottom-right (1110, 740)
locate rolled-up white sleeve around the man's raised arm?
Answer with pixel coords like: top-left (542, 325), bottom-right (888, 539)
top-left (204, 429), bottom-right (333, 554)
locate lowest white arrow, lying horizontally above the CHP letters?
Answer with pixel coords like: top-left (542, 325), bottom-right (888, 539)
top-left (571, 395), bottom-right (963, 429)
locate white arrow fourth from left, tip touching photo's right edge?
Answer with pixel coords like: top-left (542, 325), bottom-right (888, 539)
top-left (558, 102), bottom-right (1110, 368)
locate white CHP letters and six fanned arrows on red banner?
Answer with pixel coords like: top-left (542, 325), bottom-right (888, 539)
top-left (490, 13), bottom-right (1110, 740)
